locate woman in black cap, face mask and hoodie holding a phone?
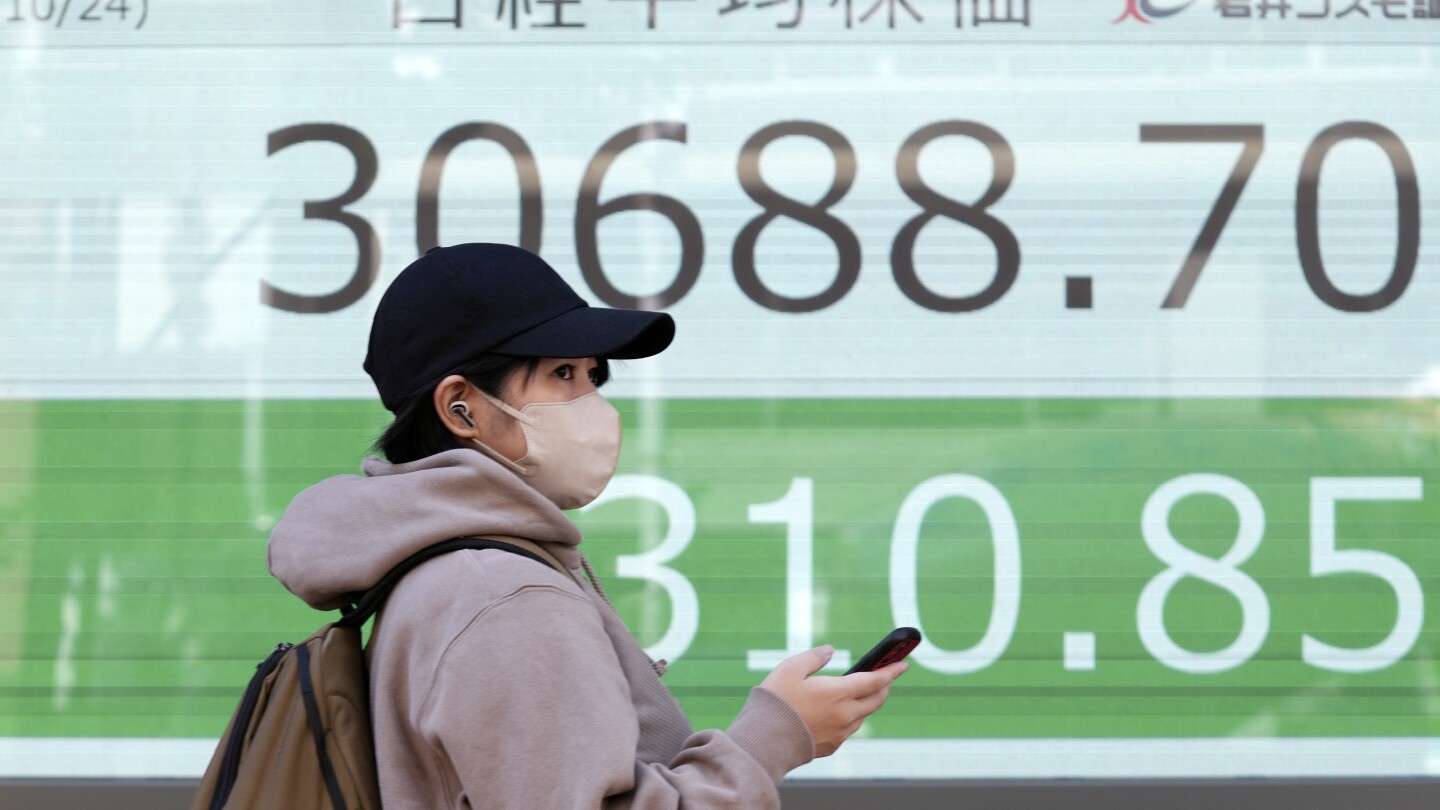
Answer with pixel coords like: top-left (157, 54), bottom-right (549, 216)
top-left (269, 245), bottom-right (904, 810)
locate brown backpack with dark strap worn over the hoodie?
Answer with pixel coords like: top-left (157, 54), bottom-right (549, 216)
top-left (190, 538), bottom-right (570, 810)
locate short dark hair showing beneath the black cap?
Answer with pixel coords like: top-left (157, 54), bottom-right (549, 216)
top-left (372, 355), bottom-right (611, 464)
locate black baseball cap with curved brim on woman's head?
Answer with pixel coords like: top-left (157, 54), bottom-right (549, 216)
top-left (364, 242), bottom-right (675, 412)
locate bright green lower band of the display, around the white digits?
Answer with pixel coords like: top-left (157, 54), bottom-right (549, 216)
top-left (0, 399), bottom-right (1440, 738)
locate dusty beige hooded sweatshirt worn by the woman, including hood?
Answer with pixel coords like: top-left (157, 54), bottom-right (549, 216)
top-left (269, 450), bottom-right (814, 810)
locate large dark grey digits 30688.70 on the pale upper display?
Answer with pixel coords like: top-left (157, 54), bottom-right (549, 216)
top-left (261, 120), bottom-right (1420, 313)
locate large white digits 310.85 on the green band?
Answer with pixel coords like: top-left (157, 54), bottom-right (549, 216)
top-left (586, 473), bottom-right (1424, 675)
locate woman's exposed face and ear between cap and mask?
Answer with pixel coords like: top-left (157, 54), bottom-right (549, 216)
top-left (435, 357), bottom-right (599, 461)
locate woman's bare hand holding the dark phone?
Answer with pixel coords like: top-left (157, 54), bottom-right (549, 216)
top-left (760, 644), bottom-right (910, 757)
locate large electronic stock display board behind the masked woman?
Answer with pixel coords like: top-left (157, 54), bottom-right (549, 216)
top-left (0, 0), bottom-right (1440, 778)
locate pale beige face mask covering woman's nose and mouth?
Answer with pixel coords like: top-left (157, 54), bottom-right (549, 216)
top-left (471, 391), bottom-right (621, 509)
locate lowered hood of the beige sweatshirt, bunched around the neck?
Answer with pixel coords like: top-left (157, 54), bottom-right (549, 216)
top-left (269, 448), bottom-right (580, 610)
